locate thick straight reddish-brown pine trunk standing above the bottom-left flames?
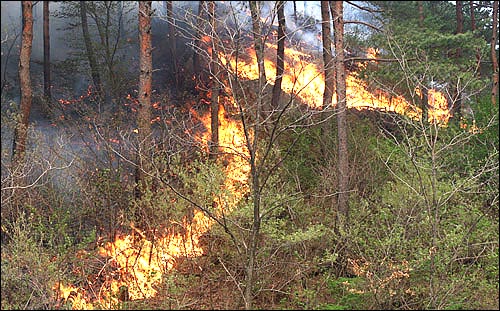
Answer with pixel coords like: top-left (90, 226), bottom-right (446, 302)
top-left (136, 1), bottom-right (153, 198)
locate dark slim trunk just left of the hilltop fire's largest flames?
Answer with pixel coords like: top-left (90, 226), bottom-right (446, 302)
top-left (271, 1), bottom-right (285, 109)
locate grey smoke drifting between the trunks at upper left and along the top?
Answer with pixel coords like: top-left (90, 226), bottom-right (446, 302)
top-left (1, 1), bottom-right (376, 195)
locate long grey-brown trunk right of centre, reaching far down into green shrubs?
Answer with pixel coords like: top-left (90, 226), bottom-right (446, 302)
top-left (330, 1), bottom-right (349, 228)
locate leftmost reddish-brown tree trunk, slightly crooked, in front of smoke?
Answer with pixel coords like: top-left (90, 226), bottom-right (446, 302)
top-left (12, 1), bottom-right (33, 164)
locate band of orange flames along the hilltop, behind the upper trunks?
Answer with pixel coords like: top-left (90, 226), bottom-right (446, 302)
top-left (220, 43), bottom-right (449, 124)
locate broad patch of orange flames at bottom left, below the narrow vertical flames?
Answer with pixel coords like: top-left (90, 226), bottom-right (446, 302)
top-left (53, 211), bottom-right (211, 309)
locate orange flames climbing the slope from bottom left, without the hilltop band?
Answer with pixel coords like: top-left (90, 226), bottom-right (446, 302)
top-left (53, 98), bottom-right (250, 309)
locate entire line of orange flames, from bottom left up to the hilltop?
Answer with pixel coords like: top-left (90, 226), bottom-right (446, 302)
top-left (54, 29), bottom-right (448, 309)
